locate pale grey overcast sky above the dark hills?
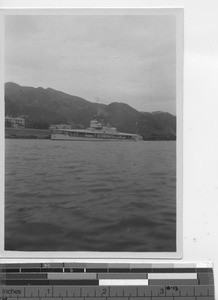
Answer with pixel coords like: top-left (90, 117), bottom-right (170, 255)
top-left (5, 15), bottom-right (176, 114)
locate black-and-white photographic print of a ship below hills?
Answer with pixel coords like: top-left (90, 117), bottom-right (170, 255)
top-left (4, 9), bottom-right (182, 256)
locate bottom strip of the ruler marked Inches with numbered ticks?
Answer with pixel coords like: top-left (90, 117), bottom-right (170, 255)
top-left (0, 285), bottom-right (214, 300)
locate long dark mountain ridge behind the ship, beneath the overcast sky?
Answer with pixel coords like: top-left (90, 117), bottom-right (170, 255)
top-left (5, 82), bottom-right (176, 140)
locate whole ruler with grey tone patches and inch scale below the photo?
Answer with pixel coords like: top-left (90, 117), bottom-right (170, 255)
top-left (0, 263), bottom-right (215, 300)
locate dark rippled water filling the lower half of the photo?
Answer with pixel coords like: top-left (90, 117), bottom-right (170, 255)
top-left (5, 139), bottom-right (176, 252)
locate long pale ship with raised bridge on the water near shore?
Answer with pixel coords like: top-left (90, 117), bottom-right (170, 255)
top-left (51, 119), bottom-right (142, 141)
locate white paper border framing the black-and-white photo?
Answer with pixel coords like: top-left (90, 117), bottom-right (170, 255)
top-left (0, 7), bottom-right (184, 260)
